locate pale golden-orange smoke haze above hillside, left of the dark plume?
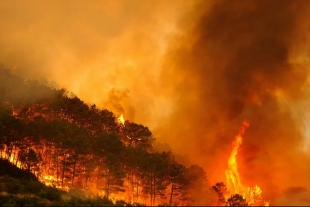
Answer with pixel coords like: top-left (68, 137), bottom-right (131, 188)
top-left (0, 0), bottom-right (194, 127)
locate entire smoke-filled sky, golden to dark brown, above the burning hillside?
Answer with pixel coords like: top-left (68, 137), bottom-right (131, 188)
top-left (0, 0), bottom-right (310, 204)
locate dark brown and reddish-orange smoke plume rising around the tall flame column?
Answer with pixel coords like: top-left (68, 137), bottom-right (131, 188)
top-left (157, 0), bottom-right (310, 201)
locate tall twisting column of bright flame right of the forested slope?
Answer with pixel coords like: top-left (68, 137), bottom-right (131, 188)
top-left (225, 121), bottom-right (269, 206)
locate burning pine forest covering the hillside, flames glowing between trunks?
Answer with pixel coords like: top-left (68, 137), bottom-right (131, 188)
top-left (0, 67), bottom-right (214, 205)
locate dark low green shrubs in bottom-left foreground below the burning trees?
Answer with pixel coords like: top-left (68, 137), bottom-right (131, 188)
top-left (0, 160), bottom-right (140, 206)
